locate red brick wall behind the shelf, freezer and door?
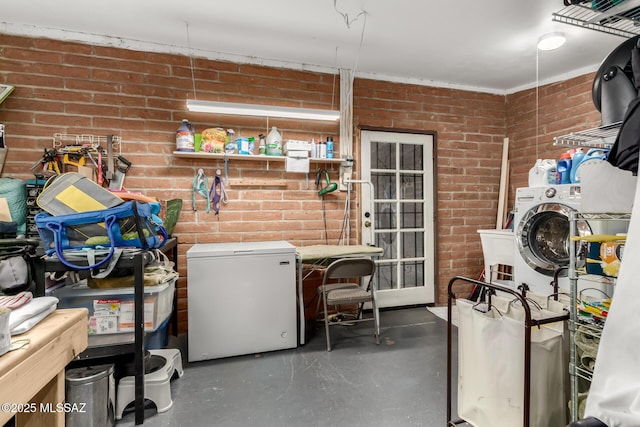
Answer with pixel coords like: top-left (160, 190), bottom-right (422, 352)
top-left (0, 35), bottom-right (597, 332)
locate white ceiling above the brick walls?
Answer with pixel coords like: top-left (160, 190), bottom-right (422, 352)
top-left (0, 0), bottom-right (624, 94)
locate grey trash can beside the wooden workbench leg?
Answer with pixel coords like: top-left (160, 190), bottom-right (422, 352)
top-left (65, 364), bottom-right (116, 427)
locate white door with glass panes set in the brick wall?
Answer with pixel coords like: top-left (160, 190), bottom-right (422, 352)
top-left (361, 131), bottom-right (435, 307)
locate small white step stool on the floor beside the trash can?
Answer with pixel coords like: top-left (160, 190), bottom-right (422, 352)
top-left (116, 349), bottom-right (184, 420)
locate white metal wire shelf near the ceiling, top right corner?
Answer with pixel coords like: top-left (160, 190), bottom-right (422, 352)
top-left (552, 0), bottom-right (640, 38)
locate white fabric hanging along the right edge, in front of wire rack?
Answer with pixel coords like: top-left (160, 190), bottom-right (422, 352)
top-left (585, 175), bottom-right (640, 427)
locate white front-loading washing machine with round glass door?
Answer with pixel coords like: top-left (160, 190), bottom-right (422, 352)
top-left (513, 184), bottom-right (626, 295)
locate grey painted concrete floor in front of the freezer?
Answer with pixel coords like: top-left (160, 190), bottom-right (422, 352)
top-left (117, 307), bottom-right (455, 427)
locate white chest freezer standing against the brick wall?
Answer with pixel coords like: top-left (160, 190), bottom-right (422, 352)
top-left (187, 241), bottom-right (298, 362)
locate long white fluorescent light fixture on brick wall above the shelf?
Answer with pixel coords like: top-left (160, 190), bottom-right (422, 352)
top-left (187, 99), bottom-right (340, 121)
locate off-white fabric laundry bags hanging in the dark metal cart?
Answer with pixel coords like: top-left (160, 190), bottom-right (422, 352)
top-left (456, 297), bottom-right (566, 427)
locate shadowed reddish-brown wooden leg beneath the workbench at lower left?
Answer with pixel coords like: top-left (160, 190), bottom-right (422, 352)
top-left (16, 370), bottom-right (65, 427)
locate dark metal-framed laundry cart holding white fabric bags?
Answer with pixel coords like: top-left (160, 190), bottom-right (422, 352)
top-left (447, 276), bottom-right (569, 427)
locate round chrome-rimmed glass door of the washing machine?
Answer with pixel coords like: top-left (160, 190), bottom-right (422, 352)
top-left (516, 203), bottom-right (591, 276)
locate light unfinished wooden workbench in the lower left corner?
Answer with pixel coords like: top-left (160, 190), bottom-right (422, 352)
top-left (0, 308), bottom-right (88, 427)
